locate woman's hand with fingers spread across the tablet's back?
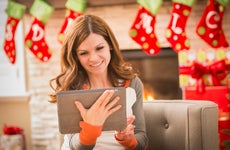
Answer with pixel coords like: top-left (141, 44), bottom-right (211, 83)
top-left (75, 90), bottom-right (121, 126)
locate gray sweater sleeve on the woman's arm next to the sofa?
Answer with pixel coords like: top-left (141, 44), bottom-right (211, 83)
top-left (130, 77), bottom-right (148, 150)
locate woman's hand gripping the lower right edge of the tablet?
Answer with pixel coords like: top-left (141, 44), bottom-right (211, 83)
top-left (115, 115), bottom-right (135, 141)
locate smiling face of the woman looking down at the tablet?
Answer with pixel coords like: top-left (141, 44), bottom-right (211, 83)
top-left (77, 33), bottom-right (111, 76)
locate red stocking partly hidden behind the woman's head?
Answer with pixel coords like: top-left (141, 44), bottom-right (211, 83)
top-left (58, 0), bottom-right (86, 43)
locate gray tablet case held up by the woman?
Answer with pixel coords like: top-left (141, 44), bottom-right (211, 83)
top-left (56, 87), bottom-right (126, 134)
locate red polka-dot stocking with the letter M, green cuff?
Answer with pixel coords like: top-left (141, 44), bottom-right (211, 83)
top-left (129, 0), bottom-right (162, 55)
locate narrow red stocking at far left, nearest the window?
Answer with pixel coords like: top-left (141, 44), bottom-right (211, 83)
top-left (3, 1), bottom-right (26, 64)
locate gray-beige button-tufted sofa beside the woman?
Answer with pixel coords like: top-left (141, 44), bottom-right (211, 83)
top-left (143, 100), bottom-right (218, 150)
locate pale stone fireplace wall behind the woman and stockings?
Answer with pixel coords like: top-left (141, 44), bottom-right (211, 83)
top-left (24, 1), bottom-right (230, 150)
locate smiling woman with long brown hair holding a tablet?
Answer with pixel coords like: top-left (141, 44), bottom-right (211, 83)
top-left (50, 15), bottom-right (148, 150)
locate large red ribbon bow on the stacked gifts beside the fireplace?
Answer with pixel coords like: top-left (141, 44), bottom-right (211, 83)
top-left (180, 60), bottom-right (230, 93)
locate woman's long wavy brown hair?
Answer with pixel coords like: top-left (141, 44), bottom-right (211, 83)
top-left (50, 15), bottom-right (137, 102)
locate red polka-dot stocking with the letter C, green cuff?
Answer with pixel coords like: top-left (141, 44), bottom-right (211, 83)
top-left (196, 0), bottom-right (229, 48)
